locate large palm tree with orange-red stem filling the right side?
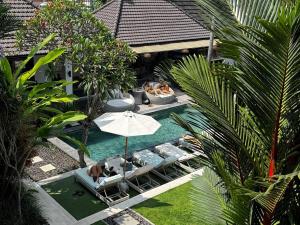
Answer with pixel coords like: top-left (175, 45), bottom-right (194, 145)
top-left (171, 0), bottom-right (300, 224)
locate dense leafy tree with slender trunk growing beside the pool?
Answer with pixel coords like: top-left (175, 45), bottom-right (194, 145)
top-left (17, 0), bottom-right (135, 167)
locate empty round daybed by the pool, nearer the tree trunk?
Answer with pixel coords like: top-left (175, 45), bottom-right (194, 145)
top-left (104, 94), bottom-right (135, 112)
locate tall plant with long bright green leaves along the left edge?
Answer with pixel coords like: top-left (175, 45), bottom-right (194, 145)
top-left (0, 35), bottom-right (88, 224)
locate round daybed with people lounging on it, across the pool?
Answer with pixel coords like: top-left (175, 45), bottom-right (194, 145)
top-left (143, 82), bottom-right (176, 105)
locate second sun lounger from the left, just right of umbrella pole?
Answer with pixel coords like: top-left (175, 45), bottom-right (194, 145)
top-left (125, 165), bottom-right (159, 193)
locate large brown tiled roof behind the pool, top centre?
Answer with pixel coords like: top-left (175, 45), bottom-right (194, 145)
top-left (95, 0), bottom-right (209, 46)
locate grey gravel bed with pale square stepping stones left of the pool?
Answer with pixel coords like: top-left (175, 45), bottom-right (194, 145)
top-left (25, 143), bottom-right (79, 181)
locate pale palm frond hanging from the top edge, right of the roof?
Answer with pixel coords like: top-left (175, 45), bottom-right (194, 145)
top-left (196, 0), bottom-right (282, 35)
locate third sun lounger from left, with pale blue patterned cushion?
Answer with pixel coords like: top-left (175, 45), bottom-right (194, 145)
top-left (133, 149), bottom-right (184, 181)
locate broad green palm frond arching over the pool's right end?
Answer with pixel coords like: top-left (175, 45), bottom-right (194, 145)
top-left (172, 56), bottom-right (267, 176)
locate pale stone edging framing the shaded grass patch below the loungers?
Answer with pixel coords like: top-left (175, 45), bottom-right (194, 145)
top-left (26, 169), bottom-right (203, 225)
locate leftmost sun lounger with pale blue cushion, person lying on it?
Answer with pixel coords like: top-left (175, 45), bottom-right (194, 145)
top-left (75, 167), bottom-right (129, 206)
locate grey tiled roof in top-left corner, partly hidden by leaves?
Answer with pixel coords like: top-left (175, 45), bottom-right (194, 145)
top-left (0, 0), bottom-right (37, 56)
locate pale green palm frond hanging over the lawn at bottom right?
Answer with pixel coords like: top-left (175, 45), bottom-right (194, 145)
top-left (191, 165), bottom-right (250, 225)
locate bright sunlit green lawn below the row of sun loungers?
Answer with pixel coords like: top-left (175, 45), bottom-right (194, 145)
top-left (133, 182), bottom-right (200, 225)
